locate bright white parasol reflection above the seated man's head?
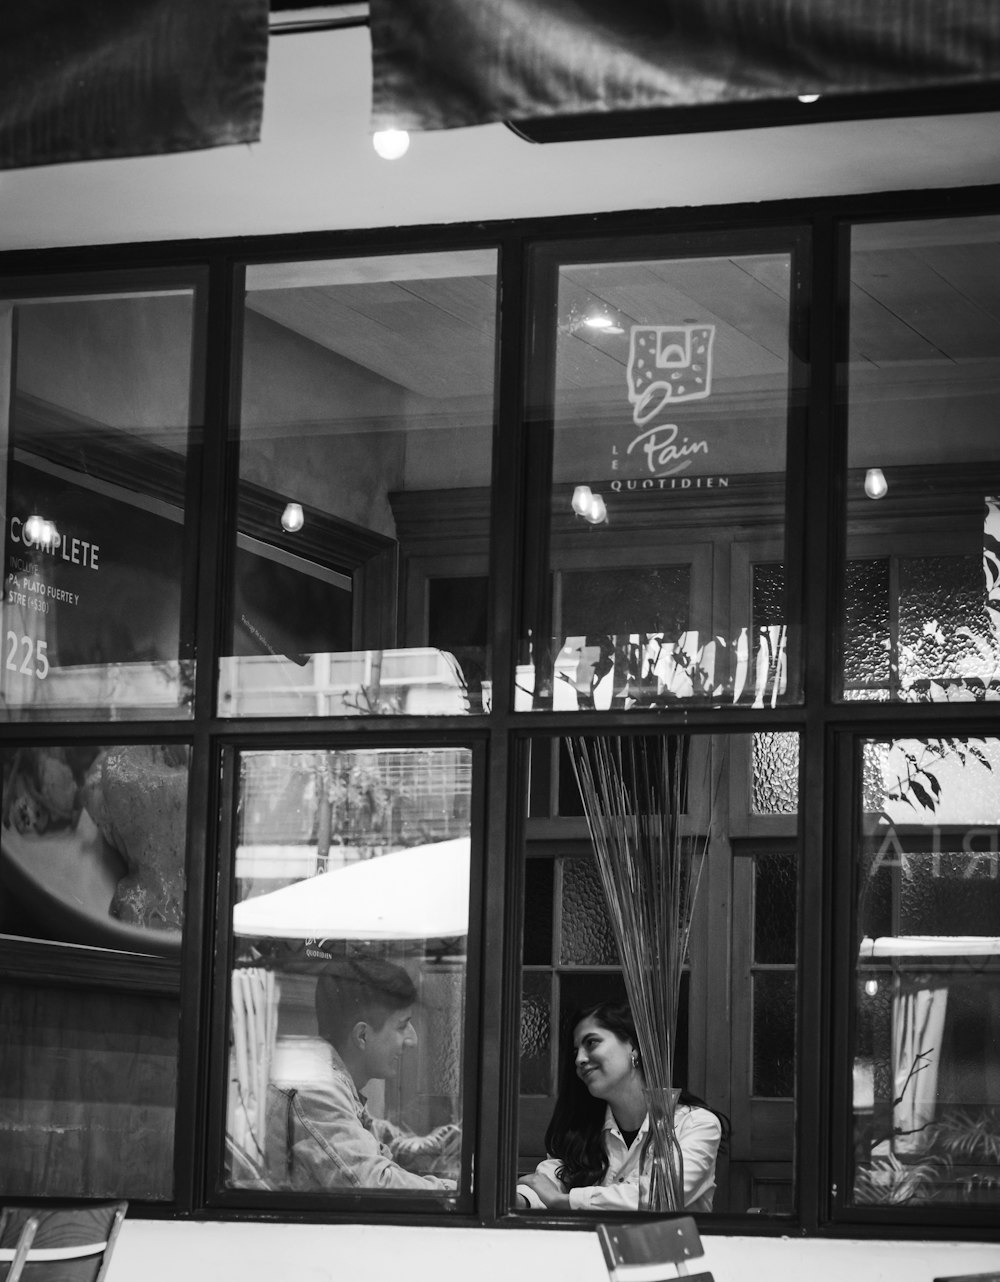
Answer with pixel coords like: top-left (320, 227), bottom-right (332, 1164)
top-left (233, 837), bottom-right (469, 940)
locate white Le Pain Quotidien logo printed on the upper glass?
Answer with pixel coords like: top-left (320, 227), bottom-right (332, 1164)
top-left (610, 324), bottom-right (729, 494)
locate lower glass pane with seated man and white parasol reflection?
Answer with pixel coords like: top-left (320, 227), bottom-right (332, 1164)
top-left (227, 747), bottom-right (472, 1204)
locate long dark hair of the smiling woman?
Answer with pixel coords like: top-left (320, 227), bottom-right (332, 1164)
top-left (545, 1001), bottom-right (729, 1188)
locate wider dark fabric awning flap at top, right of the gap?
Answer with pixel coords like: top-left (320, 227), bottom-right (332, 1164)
top-left (371, 0), bottom-right (1000, 136)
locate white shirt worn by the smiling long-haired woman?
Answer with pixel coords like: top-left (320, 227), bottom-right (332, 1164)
top-left (518, 1104), bottom-right (722, 1211)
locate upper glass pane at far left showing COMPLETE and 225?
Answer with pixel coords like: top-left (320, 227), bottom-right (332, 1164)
top-left (0, 287), bottom-right (203, 720)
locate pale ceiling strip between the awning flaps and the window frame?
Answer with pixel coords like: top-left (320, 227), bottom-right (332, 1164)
top-left (0, 27), bottom-right (1000, 250)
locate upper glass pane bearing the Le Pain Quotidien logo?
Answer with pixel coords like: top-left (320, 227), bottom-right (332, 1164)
top-left (517, 244), bottom-right (797, 710)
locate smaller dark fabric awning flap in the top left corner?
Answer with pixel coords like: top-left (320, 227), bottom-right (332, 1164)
top-left (0, 0), bottom-right (269, 169)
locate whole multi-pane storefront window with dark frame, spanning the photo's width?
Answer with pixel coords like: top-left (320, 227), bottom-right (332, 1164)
top-left (0, 194), bottom-right (1000, 1233)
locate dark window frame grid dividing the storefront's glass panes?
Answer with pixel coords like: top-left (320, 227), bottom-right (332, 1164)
top-left (0, 187), bottom-right (1000, 1238)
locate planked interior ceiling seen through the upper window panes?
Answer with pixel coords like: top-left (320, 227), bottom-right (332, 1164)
top-left (247, 218), bottom-right (1000, 401)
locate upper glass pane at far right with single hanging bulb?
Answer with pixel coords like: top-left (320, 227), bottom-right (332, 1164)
top-left (840, 217), bottom-right (1000, 703)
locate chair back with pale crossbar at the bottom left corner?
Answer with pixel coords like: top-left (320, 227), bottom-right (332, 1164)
top-left (0, 1201), bottom-right (128, 1282)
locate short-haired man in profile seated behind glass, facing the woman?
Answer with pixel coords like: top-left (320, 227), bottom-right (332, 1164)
top-left (267, 958), bottom-right (462, 1192)
